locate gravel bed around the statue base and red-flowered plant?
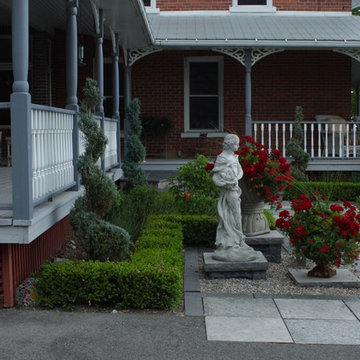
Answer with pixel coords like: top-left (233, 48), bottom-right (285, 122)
top-left (199, 248), bottom-right (360, 297)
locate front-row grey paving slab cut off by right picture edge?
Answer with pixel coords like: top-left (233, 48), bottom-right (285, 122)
top-left (285, 319), bottom-right (360, 344)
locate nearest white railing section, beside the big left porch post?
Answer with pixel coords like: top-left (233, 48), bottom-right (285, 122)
top-left (31, 104), bottom-right (75, 203)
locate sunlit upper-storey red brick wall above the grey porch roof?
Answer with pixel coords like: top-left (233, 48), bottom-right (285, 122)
top-left (156, 0), bottom-right (351, 11)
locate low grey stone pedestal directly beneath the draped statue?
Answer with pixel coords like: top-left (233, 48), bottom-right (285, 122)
top-left (204, 251), bottom-right (269, 280)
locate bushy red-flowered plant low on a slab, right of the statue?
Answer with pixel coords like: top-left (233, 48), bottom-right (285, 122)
top-left (276, 194), bottom-right (360, 278)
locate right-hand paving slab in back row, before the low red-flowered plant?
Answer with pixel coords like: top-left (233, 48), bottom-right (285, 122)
top-left (274, 298), bottom-right (356, 320)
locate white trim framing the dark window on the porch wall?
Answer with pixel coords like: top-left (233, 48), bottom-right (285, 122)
top-left (182, 56), bottom-right (224, 137)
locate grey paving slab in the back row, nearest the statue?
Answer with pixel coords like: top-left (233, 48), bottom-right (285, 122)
top-left (204, 297), bottom-right (281, 319)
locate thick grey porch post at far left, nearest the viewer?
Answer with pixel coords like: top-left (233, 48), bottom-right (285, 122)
top-left (10, 0), bottom-right (34, 220)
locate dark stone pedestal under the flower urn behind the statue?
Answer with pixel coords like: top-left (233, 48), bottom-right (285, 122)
top-left (245, 230), bottom-right (284, 263)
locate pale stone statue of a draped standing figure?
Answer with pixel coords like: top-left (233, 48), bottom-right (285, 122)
top-left (212, 134), bottom-right (257, 261)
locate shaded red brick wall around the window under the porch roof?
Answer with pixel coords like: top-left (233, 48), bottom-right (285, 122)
top-left (132, 51), bottom-right (351, 157)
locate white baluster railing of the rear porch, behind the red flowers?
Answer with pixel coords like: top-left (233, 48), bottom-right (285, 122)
top-left (252, 121), bottom-right (360, 159)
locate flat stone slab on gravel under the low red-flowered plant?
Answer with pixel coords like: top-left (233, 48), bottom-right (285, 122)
top-left (288, 269), bottom-right (360, 288)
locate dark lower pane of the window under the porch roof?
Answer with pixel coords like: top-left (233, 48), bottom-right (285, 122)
top-left (190, 97), bottom-right (219, 130)
